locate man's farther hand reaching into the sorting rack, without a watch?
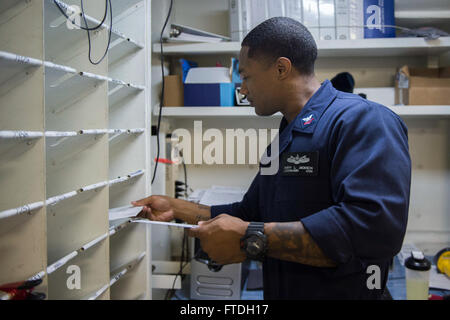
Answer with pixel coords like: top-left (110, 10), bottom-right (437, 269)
top-left (131, 196), bottom-right (175, 222)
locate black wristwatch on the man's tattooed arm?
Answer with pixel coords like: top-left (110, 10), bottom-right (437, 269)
top-left (241, 222), bottom-right (267, 261)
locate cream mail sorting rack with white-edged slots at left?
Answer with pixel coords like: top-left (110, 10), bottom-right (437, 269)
top-left (0, 0), bottom-right (151, 299)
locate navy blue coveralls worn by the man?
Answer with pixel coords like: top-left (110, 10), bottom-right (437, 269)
top-left (211, 80), bottom-right (411, 299)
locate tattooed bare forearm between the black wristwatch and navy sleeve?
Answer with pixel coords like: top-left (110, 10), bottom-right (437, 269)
top-left (265, 222), bottom-right (336, 267)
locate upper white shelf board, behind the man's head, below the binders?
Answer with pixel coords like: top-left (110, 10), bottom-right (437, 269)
top-left (153, 37), bottom-right (450, 58)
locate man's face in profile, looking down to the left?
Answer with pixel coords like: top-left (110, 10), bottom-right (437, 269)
top-left (239, 47), bottom-right (279, 116)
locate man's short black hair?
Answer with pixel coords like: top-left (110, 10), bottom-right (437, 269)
top-left (242, 17), bottom-right (317, 75)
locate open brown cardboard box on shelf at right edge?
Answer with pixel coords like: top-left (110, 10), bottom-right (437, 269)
top-left (395, 66), bottom-right (450, 105)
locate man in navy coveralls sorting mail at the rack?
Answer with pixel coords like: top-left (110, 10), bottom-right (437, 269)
top-left (133, 18), bottom-right (411, 299)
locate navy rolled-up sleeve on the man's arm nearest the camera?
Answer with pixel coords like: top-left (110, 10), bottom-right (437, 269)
top-left (301, 103), bottom-right (411, 271)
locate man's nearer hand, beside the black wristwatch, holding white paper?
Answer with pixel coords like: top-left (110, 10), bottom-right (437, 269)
top-left (189, 214), bottom-right (249, 265)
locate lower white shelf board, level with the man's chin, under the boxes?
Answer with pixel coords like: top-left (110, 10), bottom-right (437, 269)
top-left (153, 105), bottom-right (450, 119)
